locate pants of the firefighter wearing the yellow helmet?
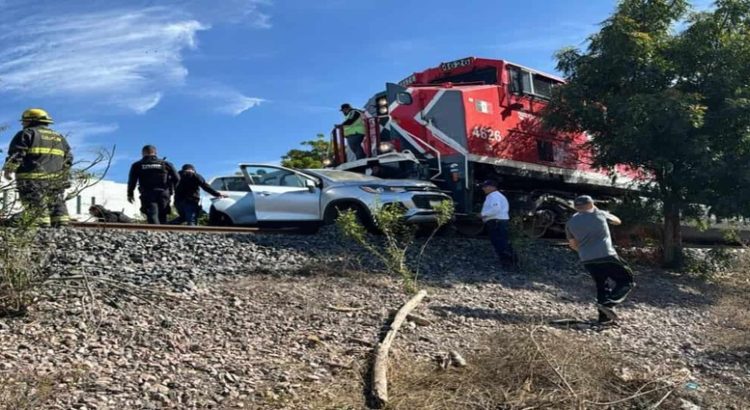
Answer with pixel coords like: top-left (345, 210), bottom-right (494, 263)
top-left (17, 180), bottom-right (70, 226)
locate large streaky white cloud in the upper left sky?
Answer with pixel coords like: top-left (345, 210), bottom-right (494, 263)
top-left (0, 8), bottom-right (208, 113)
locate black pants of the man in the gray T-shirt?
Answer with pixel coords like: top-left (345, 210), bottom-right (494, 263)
top-left (583, 256), bottom-right (635, 308)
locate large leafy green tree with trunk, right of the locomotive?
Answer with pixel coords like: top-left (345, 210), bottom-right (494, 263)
top-left (544, 0), bottom-right (750, 266)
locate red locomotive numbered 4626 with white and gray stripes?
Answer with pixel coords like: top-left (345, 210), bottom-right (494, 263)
top-left (331, 57), bottom-right (635, 235)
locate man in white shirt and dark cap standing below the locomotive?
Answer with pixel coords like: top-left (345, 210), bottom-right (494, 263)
top-left (481, 179), bottom-right (513, 266)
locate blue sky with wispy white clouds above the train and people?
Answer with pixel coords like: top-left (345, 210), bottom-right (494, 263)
top-left (0, 0), bottom-right (707, 181)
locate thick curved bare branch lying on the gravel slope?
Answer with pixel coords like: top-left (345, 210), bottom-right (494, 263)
top-left (372, 290), bottom-right (427, 408)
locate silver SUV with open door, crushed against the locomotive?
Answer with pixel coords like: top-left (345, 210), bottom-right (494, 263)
top-left (209, 164), bottom-right (451, 231)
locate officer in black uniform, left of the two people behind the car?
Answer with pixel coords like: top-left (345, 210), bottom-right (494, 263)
top-left (128, 145), bottom-right (180, 225)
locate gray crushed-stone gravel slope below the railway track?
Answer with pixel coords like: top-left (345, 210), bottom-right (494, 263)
top-left (0, 229), bottom-right (750, 409)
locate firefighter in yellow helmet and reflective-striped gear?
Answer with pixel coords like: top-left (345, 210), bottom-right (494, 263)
top-left (3, 108), bottom-right (73, 227)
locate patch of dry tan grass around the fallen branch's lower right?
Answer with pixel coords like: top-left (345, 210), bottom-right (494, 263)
top-left (304, 328), bottom-right (684, 410)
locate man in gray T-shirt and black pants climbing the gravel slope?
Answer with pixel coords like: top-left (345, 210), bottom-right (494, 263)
top-left (565, 195), bottom-right (635, 325)
